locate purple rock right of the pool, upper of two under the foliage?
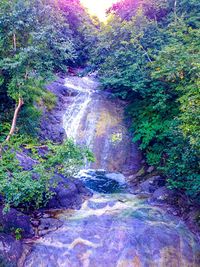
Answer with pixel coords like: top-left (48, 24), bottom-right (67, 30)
top-left (138, 176), bottom-right (165, 194)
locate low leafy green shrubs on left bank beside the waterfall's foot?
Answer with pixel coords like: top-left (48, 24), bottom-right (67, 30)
top-left (0, 136), bottom-right (93, 211)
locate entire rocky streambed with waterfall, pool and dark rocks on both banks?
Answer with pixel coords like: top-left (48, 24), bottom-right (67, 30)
top-left (0, 76), bottom-right (200, 267)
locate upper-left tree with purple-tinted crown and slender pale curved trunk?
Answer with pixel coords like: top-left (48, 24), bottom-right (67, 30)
top-left (0, 0), bottom-right (76, 141)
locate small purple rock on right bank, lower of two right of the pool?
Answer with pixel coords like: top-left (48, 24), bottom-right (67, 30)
top-left (150, 186), bottom-right (174, 203)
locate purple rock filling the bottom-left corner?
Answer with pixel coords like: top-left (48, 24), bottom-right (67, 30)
top-left (0, 233), bottom-right (23, 267)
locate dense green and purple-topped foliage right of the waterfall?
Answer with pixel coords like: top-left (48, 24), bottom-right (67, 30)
top-left (92, 0), bottom-right (200, 201)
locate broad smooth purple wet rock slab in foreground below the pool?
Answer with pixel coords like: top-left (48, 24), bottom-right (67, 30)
top-left (24, 194), bottom-right (200, 267)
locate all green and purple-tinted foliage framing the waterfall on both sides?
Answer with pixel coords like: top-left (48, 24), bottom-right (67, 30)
top-left (0, 0), bottom-right (200, 214)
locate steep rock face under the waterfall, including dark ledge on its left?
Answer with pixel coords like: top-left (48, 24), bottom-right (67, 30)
top-left (40, 76), bottom-right (141, 174)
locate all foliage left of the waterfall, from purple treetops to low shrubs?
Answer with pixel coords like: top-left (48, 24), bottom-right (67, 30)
top-left (0, 0), bottom-right (95, 213)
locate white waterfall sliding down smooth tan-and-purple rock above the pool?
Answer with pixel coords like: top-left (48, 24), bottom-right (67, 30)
top-left (63, 77), bottom-right (141, 173)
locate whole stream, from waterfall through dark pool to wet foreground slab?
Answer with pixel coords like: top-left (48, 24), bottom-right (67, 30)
top-left (23, 77), bottom-right (200, 267)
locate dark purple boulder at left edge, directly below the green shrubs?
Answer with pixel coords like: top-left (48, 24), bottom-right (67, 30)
top-left (0, 207), bottom-right (34, 238)
